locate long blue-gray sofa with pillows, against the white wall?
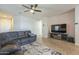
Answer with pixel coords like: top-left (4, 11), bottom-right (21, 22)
top-left (0, 31), bottom-right (36, 54)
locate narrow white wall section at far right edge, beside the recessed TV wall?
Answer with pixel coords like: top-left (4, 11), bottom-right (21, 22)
top-left (75, 5), bottom-right (79, 45)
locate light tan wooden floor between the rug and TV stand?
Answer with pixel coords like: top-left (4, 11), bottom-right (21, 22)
top-left (42, 38), bottom-right (79, 55)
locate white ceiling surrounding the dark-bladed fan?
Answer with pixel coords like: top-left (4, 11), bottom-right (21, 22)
top-left (0, 4), bottom-right (75, 19)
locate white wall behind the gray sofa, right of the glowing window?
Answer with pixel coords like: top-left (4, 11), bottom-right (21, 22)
top-left (13, 15), bottom-right (40, 35)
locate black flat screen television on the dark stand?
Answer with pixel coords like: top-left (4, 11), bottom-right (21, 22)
top-left (51, 24), bottom-right (67, 33)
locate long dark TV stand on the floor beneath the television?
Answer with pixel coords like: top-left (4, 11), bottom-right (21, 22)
top-left (50, 32), bottom-right (75, 43)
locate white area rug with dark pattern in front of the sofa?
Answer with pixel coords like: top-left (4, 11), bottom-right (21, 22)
top-left (21, 42), bottom-right (62, 55)
